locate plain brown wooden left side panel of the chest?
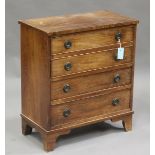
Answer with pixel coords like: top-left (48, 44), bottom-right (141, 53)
top-left (21, 25), bottom-right (50, 129)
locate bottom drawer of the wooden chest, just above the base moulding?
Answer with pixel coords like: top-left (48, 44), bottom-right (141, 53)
top-left (51, 89), bottom-right (131, 126)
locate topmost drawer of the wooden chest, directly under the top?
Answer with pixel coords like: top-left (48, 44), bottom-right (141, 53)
top-left (51, 26), bottom-right (134, 55)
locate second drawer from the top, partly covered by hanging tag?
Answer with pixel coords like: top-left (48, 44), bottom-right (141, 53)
top-left (51, 46), bottom-right (132, 77)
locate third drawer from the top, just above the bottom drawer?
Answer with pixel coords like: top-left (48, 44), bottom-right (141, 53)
top-left (51, 68), bottom-right (131, 102)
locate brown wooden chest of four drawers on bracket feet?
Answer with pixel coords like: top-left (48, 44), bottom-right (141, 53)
top-left (19, 11), bottom-right (138, 151)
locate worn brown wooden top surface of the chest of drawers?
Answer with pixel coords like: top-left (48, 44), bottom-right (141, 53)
top-left (19, 11), bottom-right (138, 36)
